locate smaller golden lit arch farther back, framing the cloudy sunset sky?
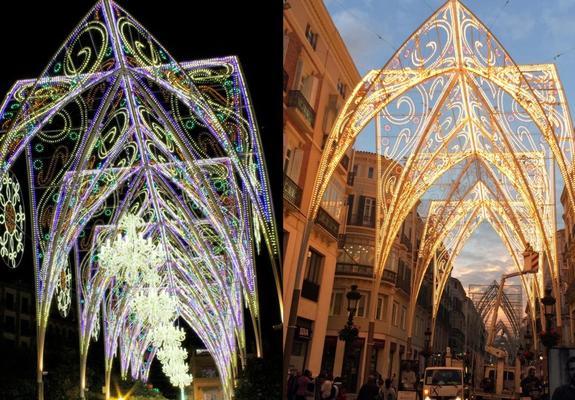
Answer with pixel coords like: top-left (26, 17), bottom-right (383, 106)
top-left (408, 154), bottom-right (553, 344)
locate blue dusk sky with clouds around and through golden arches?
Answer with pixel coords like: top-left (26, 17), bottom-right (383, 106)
top-left (324, 0), bottom-right (575, 289)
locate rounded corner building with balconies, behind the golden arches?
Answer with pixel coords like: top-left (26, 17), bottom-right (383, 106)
top-left (322, 151), bottom-right (431, 392)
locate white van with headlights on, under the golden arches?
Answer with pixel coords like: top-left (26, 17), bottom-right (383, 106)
top-left (423, 367), bottom-right (469, 400)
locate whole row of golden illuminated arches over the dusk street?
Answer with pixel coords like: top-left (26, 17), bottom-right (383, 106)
top-left (298, 0), bottom-right (575, 354)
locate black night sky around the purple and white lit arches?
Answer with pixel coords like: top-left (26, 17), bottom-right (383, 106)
top-left (0, 0), bottom-right (283, 397)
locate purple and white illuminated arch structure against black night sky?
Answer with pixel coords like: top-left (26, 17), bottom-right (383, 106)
top-left (0, 0), bottom-right (281, 398)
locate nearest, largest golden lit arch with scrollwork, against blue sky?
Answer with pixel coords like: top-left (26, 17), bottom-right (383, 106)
top-left (306, 0), bottom-right (574, 344)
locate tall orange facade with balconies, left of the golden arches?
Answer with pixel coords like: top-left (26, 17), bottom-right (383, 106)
top-left (283, 0), bottom-right (360, 375)
